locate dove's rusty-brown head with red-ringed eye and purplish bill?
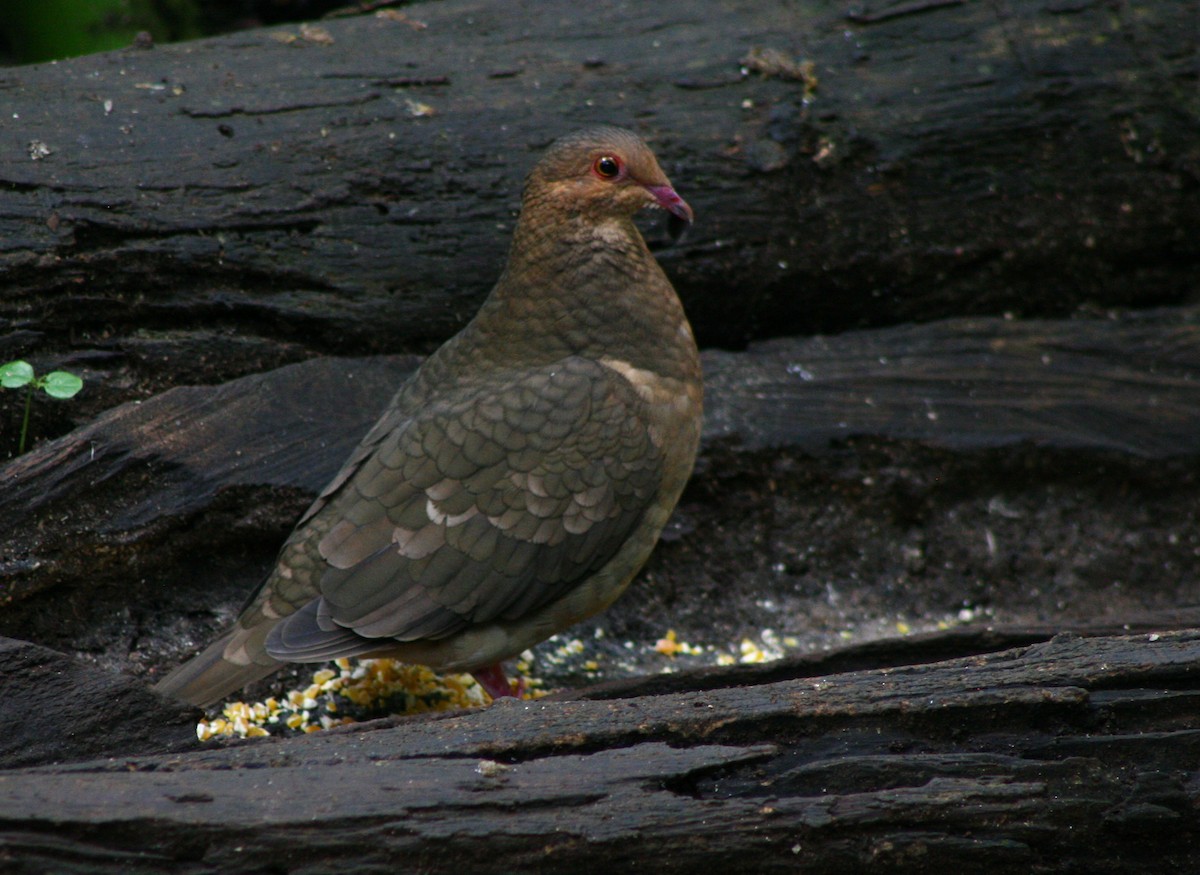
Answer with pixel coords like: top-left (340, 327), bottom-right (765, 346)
top-left (526, 126), bottom-right (692, 230)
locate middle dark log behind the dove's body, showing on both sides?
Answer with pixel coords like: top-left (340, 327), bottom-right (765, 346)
top-left (0, 313), bottom-right (1200, 673)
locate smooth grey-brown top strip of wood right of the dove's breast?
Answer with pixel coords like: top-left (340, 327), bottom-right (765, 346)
top-left (704, 307), bottom-right (1200, 459)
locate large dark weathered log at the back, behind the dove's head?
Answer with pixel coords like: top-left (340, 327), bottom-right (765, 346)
top-left (0, 0), bottom-right (1200, 415)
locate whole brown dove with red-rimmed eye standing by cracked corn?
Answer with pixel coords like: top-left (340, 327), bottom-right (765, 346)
top-left (156, 127), bottom-right (702, 706)
